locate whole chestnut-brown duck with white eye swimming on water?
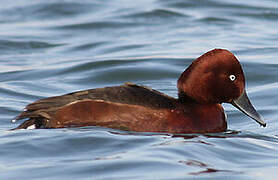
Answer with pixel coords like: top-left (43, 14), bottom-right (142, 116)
top-left (13, 49), bottom-right (266, 133)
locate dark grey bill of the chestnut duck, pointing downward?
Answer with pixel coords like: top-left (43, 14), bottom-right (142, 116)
top-left (231, 91), bottom-right (266, 127)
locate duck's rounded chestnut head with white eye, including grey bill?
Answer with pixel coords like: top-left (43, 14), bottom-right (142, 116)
top-left (177, 49), bottom-right (266, 127)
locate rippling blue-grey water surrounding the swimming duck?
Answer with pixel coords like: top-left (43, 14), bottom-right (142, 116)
top-left (0, 0), bottom-right (278, 180)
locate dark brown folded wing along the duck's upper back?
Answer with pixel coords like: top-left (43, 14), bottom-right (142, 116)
top-left (13, 83), bottom-right (176, 122)
